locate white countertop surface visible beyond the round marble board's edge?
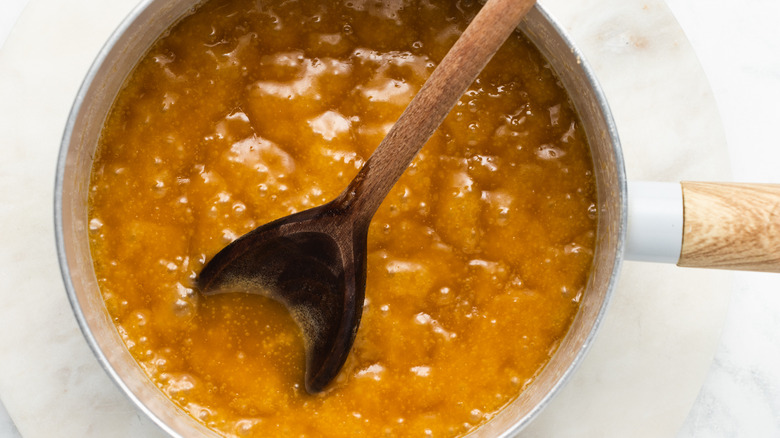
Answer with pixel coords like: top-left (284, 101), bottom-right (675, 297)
top-left (0, 0), bottom-right (780, 438)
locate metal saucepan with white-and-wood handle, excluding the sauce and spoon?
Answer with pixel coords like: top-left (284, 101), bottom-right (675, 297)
top-left (55, 0), bottom-right (780, 437)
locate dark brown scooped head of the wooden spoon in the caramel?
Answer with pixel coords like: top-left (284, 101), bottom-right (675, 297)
top-left (193, 195), bottom-right (368, 393)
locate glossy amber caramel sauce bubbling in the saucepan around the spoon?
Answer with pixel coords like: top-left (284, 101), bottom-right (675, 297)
top-left (89, 0), bottom-right (596, 437)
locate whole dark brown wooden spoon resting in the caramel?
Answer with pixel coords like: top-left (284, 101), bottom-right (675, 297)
top-left (198, 0), bottom-right (534, 393)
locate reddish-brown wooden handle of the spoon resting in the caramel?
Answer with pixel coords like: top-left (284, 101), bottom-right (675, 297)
top-left (339, 0), bottom-right (535, 221)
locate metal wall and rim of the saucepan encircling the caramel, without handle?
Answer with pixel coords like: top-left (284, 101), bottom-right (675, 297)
top-left (55, 0), bottom-right (626, 437)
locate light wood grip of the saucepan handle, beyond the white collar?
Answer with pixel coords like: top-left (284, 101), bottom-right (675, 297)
top-left (677, 182), bottom-right (780, 272)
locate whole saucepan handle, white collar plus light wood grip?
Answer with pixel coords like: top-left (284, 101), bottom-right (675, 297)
top-left (626, 182), bottom-right (780, 272)
